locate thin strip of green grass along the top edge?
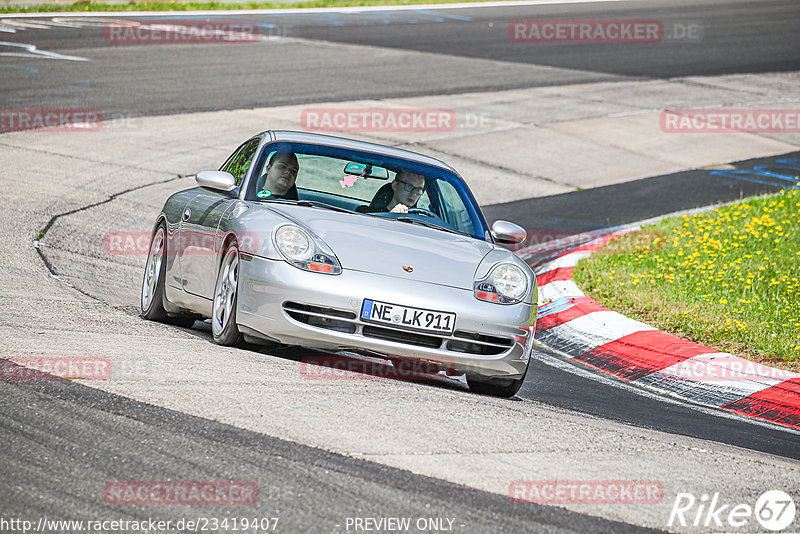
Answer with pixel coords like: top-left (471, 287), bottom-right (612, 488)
top-left (0, 0), bottom-right (512, 13)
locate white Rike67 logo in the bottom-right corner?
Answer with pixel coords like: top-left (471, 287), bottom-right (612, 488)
top-left (667, 490), bottom-right (796, 532)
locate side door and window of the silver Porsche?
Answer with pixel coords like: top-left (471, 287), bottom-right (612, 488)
top-left (179, 138), bottom-right (261, 299)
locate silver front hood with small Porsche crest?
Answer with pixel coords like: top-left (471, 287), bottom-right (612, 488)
top-left (271, 206), bottom-right (494, 290)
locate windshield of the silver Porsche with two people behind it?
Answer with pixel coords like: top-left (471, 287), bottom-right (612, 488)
top-left (245, 143), bottom-right (488, 240)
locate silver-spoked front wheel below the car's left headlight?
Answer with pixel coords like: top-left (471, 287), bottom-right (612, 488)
top-left (211, 242), bottom-right (243, 346)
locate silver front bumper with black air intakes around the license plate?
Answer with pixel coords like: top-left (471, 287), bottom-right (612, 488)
top-left (237, 255), bottom-right (536, 379)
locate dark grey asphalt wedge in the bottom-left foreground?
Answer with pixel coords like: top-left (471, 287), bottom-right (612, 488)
top-left (2, 382), bottom-right (647, 532)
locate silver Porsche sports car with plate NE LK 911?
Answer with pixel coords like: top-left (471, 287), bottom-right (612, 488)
top-left (142, 131), bottom-right (537, 397)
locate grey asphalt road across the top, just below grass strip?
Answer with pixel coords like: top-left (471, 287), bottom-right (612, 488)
top-left (0, 0), bottom-right (800, 115)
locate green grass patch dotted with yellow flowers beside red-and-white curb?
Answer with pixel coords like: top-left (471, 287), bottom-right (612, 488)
top-left (575, 189), bottom-right (800, 370)
